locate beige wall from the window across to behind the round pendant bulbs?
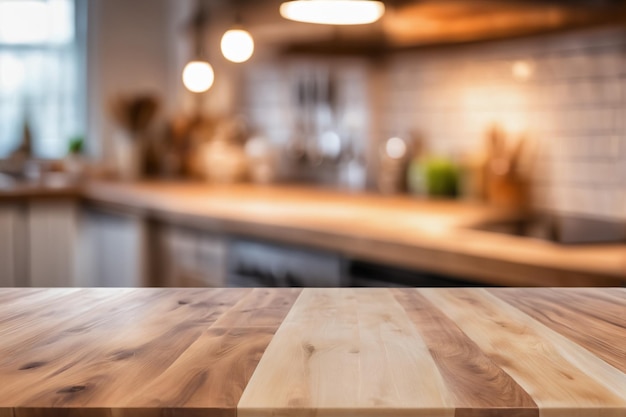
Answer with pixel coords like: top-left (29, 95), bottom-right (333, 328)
top-left (87, 0), bottom-right (240, 160)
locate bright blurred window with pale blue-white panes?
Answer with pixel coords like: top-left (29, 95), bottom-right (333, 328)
top-left (0, 0), bottom-right (85, 158)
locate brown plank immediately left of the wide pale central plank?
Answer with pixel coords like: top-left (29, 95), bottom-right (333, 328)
top-left (127, 289), bottom-right (301, 408)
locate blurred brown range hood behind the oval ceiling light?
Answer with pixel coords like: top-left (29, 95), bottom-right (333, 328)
top-left (222, 0), bottom-right (626, 55)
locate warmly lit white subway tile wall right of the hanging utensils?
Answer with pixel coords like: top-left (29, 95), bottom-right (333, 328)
top-left (386, 29), bottom-right (626, 219)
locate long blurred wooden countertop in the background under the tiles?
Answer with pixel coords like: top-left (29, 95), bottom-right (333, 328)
top-left (83, 182), bottom-right (626, 286)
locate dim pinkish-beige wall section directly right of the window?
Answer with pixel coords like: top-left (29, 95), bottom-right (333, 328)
top-left (87, 0), bottom-right (171, 158)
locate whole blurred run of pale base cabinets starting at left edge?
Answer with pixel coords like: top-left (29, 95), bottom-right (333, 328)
top-left (0, 198), bottom-right (227, 287)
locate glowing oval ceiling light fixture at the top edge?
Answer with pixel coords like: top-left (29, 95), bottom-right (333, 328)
top-left (280, 0), bottom-right (385, 25)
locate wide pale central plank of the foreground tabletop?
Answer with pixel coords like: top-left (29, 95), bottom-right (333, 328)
top-left (238, 289), bottom-right (454, 417)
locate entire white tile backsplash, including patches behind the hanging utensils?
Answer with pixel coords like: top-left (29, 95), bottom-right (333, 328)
top-left (246, 29), bottom-right (626, 219)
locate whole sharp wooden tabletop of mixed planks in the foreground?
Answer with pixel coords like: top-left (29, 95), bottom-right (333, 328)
top-left (0, 288), bottom-right (626, 417)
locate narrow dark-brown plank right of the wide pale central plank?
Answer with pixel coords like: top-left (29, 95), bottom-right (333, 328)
top-left (392, 289), bottom-right (539, 417)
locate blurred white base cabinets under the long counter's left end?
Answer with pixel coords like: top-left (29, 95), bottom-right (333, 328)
top-left (76, 205), bottom-right (226, 287)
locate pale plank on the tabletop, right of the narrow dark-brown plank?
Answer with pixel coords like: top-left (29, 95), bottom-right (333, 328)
top-left (419, 289), bottom-right (626, 417)
